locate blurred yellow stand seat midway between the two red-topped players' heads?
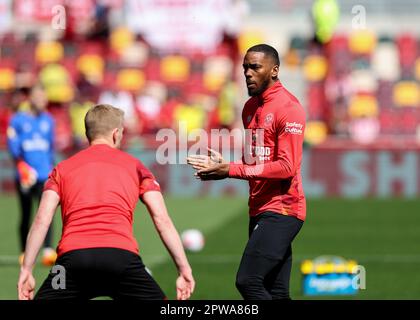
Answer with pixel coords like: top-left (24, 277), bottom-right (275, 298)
top-left (160, 56), bottom-right (190, 82)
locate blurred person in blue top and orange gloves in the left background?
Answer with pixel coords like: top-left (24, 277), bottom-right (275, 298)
top-left (7, 85), bottom-right (56, 265)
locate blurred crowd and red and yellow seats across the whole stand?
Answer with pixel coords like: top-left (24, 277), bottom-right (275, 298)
top-left (0, 3), bottom-right (420, 150)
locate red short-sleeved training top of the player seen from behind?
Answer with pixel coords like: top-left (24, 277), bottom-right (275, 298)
top-left (44, 144), bottom-right (160, 256)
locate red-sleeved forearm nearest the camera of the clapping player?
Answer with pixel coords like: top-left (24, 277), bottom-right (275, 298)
top-left (229, 160), bottom-right (296, 180)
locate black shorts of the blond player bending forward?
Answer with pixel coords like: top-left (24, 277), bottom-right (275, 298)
top-left (35, 248), bottom-right (166, 300)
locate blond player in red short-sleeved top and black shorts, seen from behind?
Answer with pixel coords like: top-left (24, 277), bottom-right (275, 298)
top-left (18, 105), bottom-right (194, 300)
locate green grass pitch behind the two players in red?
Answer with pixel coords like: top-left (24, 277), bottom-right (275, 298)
top-left (0, 196), bottom-right (420, 299)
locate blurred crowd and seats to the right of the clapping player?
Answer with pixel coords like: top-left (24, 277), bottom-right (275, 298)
top-left (290, 30), bottom-right (420, 144)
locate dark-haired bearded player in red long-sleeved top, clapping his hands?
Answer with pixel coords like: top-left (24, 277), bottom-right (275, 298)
top-left (188, 44), bottom-right (306, 299)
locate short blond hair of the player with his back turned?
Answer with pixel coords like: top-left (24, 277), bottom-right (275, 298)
top-left (85, 104), bottom-right (124, 142)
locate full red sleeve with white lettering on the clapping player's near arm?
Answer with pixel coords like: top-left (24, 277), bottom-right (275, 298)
top-left (229, 104), bottom-right (305, 180)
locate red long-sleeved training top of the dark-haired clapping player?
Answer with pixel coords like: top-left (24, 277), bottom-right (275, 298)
top-left (229, 82), bottom-right (306, 220)
